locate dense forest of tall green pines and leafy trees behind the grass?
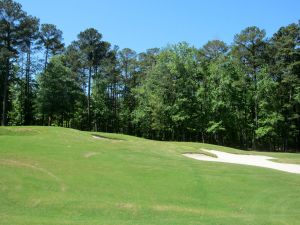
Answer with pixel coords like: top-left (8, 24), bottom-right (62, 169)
top-left (0, 0), bottom-right (300, 151)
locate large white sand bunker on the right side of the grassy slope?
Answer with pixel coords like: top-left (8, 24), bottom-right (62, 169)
top-left (183, 149), bottom-right (300, 174)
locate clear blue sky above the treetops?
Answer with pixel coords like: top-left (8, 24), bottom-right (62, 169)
top-left (17, 0), bottom-right (300, 52)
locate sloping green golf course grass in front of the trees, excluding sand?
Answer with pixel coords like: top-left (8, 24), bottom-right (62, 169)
top-left (0, 127), bottom-right (300, 225)
